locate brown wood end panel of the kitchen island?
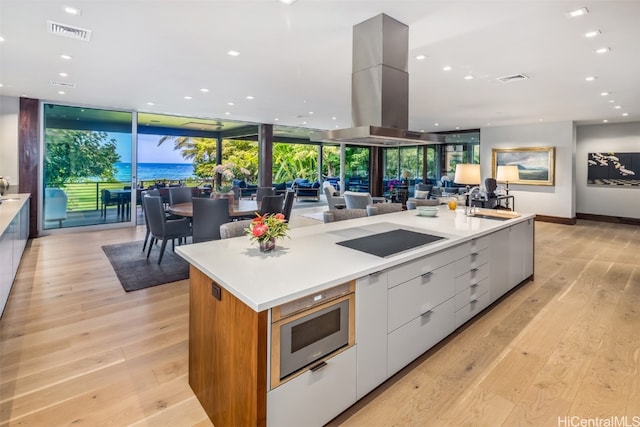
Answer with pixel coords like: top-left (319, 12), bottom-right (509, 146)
top-left (189, 266), bottom-right (267, 427)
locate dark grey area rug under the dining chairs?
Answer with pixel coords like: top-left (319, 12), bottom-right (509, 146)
top-left (102, 241), bottom-right (189, 292)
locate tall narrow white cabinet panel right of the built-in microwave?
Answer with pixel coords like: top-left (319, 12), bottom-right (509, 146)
top-left (356, 272), bottom-right (388, 399)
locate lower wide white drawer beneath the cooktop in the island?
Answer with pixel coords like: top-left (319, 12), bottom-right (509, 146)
top-left (387, 298), bottom-right (455, 376)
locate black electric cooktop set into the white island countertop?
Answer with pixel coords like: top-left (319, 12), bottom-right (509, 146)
top-left (336, 228), bottom-right (444, 258)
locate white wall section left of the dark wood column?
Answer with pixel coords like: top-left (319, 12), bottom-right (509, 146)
top-left (0, 96), bottom-right (20, 193)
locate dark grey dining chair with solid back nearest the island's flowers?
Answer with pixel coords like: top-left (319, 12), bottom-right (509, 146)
top-left (191, 197), bottom-right (230, 243)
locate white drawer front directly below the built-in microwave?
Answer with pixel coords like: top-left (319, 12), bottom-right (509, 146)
top-left (267, 346), bottom-right (356, 426)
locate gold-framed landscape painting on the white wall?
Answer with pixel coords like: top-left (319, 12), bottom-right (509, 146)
top-left (492, 147), bottom-right (555, 185)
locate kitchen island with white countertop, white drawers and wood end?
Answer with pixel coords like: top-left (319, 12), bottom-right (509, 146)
top-left (176, 206), bottom-right (534, 427)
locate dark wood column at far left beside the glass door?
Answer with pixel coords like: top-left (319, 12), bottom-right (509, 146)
top-left (18, 98), bottom-right (40, 239)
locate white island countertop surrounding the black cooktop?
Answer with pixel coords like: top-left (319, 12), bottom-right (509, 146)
top-left (176, 206), bottom-right (534, 312)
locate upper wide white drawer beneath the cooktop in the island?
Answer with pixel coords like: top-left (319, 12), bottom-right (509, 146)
top-left (387, 264), bottom-right (455, 332)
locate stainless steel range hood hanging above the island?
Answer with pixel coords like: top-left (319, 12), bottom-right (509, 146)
top-left (310, 14), bottom-right (444, 147)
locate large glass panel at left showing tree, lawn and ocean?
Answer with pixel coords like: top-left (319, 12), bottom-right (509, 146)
top-left (41, 103), bottom-right (134, 230)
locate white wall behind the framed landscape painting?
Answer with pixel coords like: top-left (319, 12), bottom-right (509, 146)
top-left (480, 122), bottom-right (576, 218)
